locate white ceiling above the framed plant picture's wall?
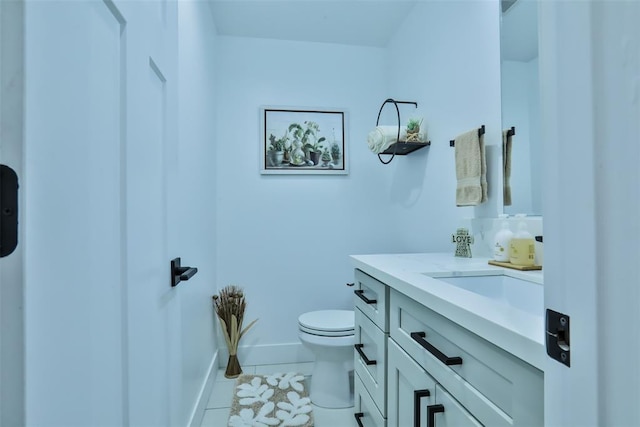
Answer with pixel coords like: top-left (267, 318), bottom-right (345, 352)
top-left (210, 0), bottom-right (420, 47)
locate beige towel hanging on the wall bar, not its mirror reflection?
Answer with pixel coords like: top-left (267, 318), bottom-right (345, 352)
top-left (455, 129), bottom-right (487, 206)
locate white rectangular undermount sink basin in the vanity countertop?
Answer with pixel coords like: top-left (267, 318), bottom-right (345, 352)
top-left (429, 274), bottom-right (544, 316)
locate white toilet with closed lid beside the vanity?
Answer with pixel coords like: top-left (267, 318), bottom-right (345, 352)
top-left (298, 310), bottom-right (355, 408)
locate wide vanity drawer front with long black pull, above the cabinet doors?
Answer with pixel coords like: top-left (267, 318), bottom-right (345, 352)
top-left (389, 291), bottom-right (544, 426)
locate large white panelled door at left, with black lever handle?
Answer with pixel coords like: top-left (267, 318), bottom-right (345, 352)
top-left (23, 0), bottom-right (181, 426)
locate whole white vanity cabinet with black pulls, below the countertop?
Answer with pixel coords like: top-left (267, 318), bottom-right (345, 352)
top-left (354, 269), bottom-right (544, 427)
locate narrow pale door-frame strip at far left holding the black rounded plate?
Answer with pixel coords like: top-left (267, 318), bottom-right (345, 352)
top-left (0, 2), bottom-right (24, 426)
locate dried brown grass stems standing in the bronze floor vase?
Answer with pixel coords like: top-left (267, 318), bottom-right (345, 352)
top-left (213, 285), bottom-right (258, 356)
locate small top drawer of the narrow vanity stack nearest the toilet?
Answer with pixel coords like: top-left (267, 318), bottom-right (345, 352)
top-left (353, 269), bottom-right (389, 332)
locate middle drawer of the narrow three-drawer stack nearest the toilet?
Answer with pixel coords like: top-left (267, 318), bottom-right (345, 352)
top-left (354, 309), bottom-right (387, 416)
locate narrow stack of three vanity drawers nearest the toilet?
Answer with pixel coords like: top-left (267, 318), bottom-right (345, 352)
top-left (354, 270), bottom-right (389, 427)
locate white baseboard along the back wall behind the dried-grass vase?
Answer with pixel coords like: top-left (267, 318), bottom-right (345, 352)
top-left (219, 342), bottom-right (314, 368)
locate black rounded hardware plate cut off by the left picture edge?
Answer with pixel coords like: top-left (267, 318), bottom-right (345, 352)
top-left (0, 165), bottom-right (18, 257)
